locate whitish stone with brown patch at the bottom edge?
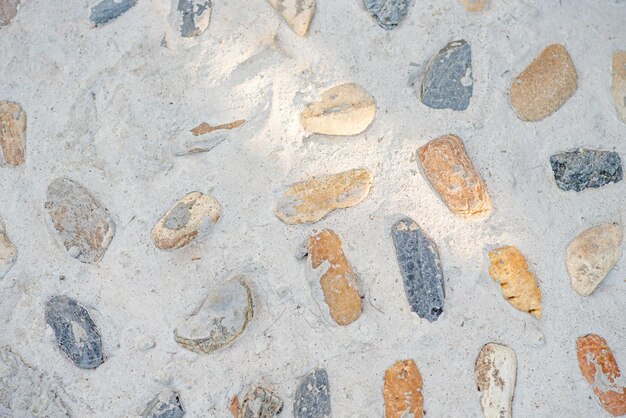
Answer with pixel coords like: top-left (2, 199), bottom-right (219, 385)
top-left (476, 343), bottom-right (517, 418)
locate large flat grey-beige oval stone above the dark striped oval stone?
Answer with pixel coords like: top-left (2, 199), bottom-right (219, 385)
top-left (44, 178), bottom-right (115, 264)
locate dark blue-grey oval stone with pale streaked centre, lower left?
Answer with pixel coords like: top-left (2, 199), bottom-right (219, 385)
top-left (46, 296), bottom-right (104, 369)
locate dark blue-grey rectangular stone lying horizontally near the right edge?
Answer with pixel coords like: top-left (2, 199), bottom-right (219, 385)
top-left (550, 148), bottom-right (624, 192)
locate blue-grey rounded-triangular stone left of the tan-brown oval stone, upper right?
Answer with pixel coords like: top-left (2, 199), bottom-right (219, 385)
top-left (420, 40), bottom-right (474, 110)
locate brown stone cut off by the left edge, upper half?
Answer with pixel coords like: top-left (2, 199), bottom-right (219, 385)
top-left (0, 100), bottom-right (26, 166)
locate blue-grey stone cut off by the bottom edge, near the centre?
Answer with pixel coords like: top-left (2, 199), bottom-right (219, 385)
top-left (293, 369), bottom-right (331, 418)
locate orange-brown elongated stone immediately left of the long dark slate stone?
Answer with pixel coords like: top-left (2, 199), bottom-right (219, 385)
top-left (308, 229), bottom-right (363, 325)
